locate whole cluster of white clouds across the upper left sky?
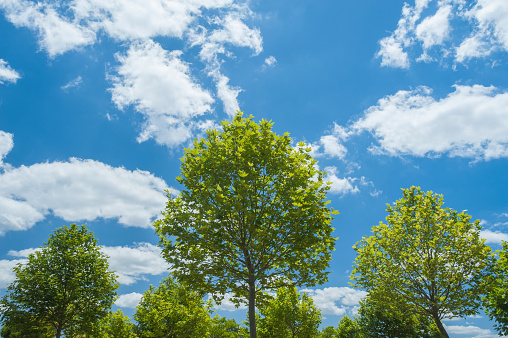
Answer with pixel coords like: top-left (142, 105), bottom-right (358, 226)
top-left (0, 0), bottom-right (268, 147)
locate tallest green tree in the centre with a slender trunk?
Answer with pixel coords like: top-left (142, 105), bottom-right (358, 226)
top-left (155, 112), bottom-right (336, 338)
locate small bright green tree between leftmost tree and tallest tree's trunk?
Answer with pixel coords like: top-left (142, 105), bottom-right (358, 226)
top-left (134, 276), bottom-right (212, 338)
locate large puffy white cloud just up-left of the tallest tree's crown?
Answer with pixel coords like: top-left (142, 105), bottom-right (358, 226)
top-left (110, 41), bottom-right (214, 146)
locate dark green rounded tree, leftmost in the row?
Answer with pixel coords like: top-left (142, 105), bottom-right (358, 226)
top-left (0, 224), bottom-right (118, 337)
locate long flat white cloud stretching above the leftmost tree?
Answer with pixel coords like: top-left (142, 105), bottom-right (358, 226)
top-left (0, 158), bottom-right (174, 233)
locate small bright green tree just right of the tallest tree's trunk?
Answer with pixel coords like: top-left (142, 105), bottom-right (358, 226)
top-left (257, 287), bottom-right (321, 338)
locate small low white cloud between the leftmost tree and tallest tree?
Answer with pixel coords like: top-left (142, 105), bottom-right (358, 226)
top-left (101, 243), bottom-right (170, 285)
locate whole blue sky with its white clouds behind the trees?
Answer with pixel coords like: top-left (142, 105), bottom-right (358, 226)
top-left (0, 0), bottom-right (508, 337)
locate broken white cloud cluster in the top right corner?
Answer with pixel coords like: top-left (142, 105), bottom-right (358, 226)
top-left (377, 0), bottom-right (508, 69)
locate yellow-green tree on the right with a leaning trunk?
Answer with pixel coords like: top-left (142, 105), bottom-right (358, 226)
top-left (351, 187), bottom-right (494, 337)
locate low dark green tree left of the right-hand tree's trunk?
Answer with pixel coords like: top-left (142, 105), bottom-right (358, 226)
top-left (356, 296), bottom-right (441, 338)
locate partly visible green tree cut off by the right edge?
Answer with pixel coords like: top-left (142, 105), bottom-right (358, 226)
top-left (485, 242), bottom-right (508, 335)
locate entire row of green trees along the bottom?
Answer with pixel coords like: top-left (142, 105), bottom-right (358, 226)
top-left (0, 112), bottom-right (508, 338)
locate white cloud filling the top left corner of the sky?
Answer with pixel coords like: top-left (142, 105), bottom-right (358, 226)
top-left (0, 0), bottom-right (96, 57)
